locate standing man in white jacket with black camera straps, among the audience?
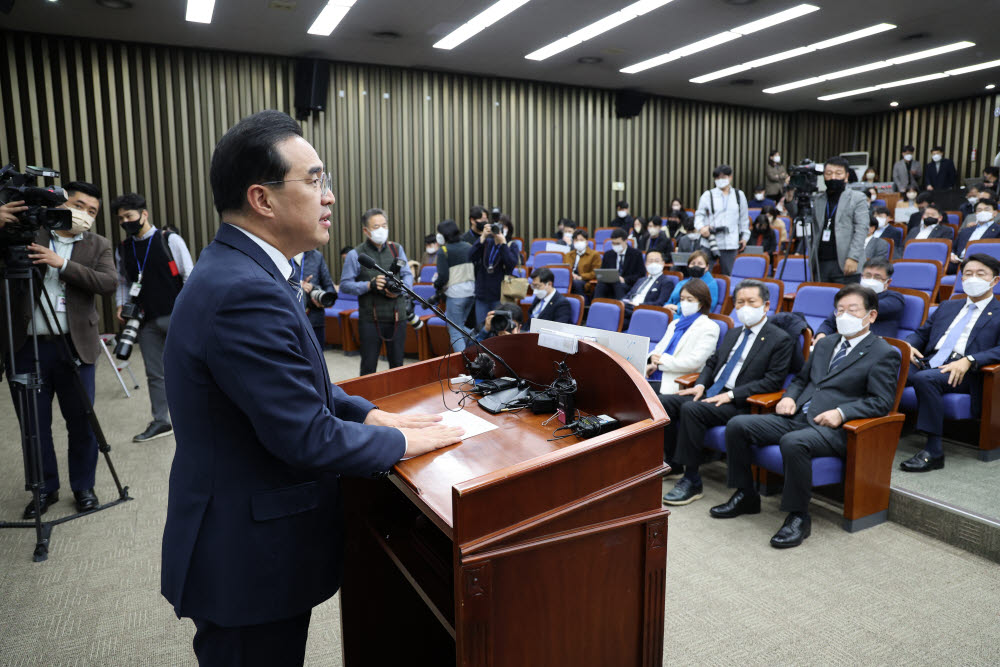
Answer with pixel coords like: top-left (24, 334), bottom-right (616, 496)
top-left (694, 164), bottom-right (750, 276)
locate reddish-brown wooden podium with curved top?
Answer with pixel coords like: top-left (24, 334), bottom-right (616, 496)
top-left (340, 334), bottom-right (669, 667)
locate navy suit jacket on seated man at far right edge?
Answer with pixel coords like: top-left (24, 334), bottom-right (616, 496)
top-left (906, 299), bottom-right (1000, 416)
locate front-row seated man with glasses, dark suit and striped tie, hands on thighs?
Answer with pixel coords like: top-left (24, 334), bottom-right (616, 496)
top-left (710, 285), bottom-right (899, 549)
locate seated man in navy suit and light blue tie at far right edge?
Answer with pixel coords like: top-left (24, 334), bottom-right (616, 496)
top-left (899, 254), bottom-right (1000, 472)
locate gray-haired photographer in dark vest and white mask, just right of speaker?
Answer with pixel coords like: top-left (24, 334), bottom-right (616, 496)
top-left (340, 208), bottom-right (413, 375)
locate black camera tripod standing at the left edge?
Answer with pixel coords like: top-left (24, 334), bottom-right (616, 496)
top-left (0, 246), bottom-right (132, 563)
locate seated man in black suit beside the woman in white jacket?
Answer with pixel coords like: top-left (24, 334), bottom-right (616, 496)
top-left (660, 279), bottom-right (794, 505)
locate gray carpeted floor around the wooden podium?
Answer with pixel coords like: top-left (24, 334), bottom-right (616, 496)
top-left (0, 352), bottom-right (1000, 666)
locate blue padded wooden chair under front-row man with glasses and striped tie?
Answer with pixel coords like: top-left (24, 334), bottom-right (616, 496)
top-left (750, 340), bottom-right (910, 533)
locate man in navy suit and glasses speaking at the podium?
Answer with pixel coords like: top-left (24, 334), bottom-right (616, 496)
top-left (161, 111), bottom-right (462, 665)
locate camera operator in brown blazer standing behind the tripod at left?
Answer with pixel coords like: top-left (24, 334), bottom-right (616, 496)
top-left (0, 181), bottom-right (117, 519)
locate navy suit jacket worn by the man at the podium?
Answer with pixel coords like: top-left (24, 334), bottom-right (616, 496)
top-left (161, 224), bottom-right (406, 626)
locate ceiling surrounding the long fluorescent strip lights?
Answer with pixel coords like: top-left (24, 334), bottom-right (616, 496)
top-left (0, 0), bottom-right (1000, 114)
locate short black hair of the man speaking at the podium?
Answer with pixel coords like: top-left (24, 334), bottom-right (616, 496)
top-left (209, 109), bottom-right (302, 214)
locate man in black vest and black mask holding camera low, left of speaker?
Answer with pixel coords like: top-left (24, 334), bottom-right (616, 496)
top-left (111, 192), bottom-right (194, 442)
